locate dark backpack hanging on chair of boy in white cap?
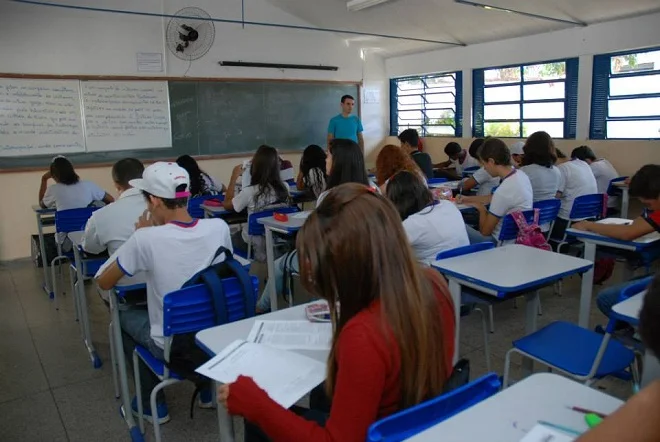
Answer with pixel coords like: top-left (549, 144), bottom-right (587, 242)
top-left (166, 247), bottom-right (254, 418)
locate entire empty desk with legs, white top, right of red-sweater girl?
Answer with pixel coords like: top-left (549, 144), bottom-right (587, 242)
top-left (431, 244), bottom-right (593, 362)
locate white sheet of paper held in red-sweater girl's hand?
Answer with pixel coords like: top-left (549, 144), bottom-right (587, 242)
top-left (196, 340), bottom-right (326, 408)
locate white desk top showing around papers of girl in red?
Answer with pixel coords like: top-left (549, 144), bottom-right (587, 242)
top-left (195, 304), bottom-right (329, 362)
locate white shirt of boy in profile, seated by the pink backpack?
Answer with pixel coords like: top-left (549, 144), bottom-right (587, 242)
top-left (488, 169), bottom-right (534, 239)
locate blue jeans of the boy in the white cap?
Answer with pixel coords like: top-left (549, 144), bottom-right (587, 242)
top-left (119, 309), bottom-right (165, 413)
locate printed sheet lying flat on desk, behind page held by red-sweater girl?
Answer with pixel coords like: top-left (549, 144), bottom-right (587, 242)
top-left (247, 320), bottom-right (332, 350)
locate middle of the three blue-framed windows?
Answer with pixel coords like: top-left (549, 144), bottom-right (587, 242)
top-left (472, 58), bottom-right (578, 138)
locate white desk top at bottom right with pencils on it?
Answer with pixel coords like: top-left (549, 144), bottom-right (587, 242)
top-left (408, 373), bottom-right (623, 442)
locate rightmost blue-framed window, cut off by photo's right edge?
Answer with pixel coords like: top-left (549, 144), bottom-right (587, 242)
top-left (590, 48), bottom-right (660, 140)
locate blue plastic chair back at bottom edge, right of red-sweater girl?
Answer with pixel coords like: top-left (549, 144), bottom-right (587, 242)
top-left (367, 373), bottom-right (502, 442)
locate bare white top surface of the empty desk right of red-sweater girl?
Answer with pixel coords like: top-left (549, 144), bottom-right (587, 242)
top-left (431, 244), bottom-right (593, 294)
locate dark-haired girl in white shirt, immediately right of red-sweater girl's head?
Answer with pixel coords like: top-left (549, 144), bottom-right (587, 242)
top-left (387, 170), bottom-right (470, 264)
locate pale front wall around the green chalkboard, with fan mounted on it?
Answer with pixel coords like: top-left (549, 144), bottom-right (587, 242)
top-left (0, 0), bottom-right (389, 261)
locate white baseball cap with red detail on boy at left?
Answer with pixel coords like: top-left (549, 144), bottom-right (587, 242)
top-left (128, 161), bottom-right (190, 199)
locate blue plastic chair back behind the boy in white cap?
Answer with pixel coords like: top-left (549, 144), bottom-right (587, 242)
top-left (163, 276), bottom-right (259, 336)
